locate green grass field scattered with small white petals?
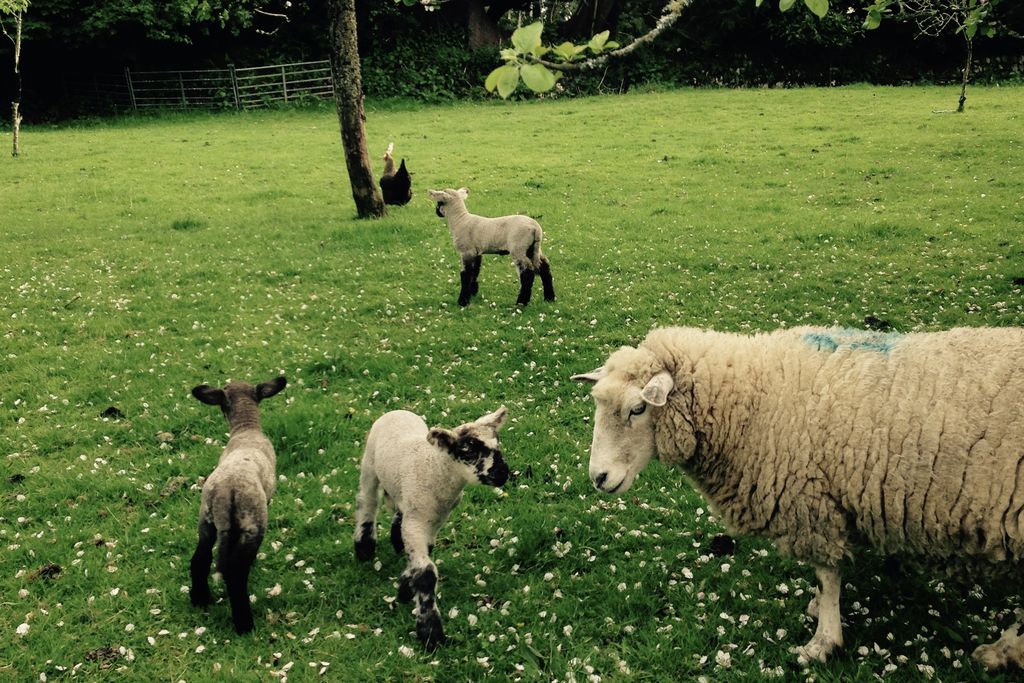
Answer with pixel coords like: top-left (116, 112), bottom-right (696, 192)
top-left (0, 87), bottom-right (1024, 683)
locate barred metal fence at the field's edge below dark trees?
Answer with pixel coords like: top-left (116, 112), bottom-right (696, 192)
top-left (120, 59), bottom-right (334, 112)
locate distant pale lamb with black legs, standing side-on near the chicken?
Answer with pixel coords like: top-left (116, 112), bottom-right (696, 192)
top-left (427, 187), bottom-right (555, 306)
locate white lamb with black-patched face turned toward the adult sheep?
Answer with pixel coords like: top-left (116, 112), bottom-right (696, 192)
top-left (355, 405), bottom-right (509, 648)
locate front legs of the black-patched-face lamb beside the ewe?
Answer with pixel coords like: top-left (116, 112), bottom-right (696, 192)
top-left (398, 515), bottom-right (444, 649)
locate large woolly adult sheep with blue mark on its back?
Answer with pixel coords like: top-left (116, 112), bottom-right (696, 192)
top-left (573, 328), bottom-right (1024, 669)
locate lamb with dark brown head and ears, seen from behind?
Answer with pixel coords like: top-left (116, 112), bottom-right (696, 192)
top-left (190, 377), bottom-right (288, 633)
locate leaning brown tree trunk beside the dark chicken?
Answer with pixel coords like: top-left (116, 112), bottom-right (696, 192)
top-left (327, 0), bottom-right (387, 218)
